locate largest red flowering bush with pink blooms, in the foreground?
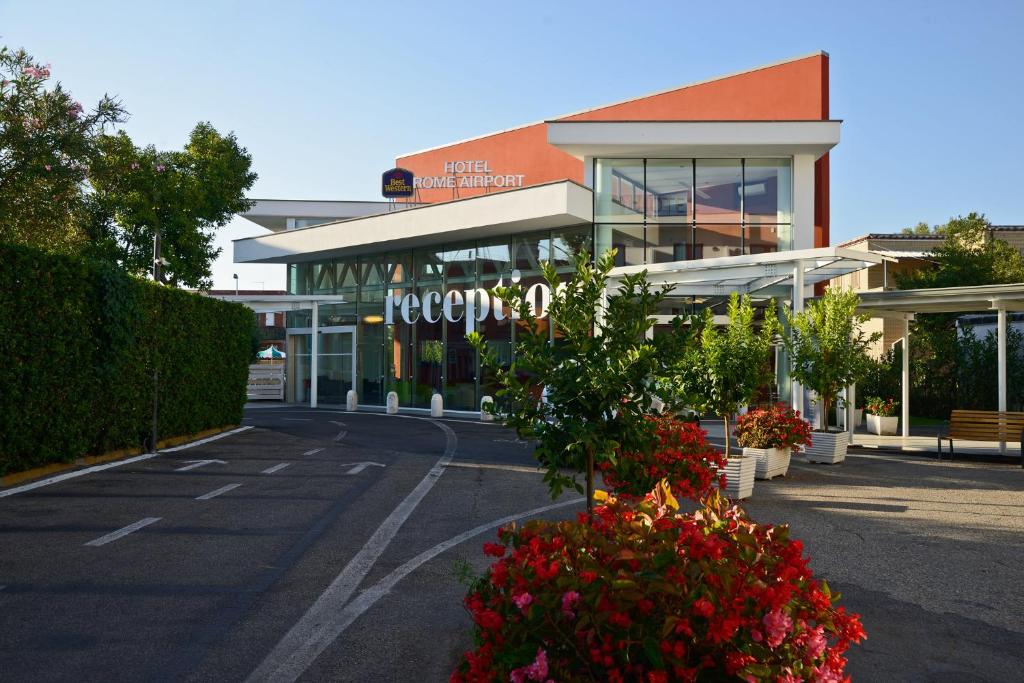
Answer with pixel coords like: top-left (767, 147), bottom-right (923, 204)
top-left (451, 485), bottom-right (864, 683)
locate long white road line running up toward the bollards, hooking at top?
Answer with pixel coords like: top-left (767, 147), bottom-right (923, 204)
top-left (246, 416), bottom-right (458, 683)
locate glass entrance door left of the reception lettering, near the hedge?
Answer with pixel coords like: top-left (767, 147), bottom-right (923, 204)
top-left (288, 326), bottom-right (355, 404)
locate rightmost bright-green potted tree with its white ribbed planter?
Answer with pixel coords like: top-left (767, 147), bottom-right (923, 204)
top-left (782, 287), bottom-right (882, 465)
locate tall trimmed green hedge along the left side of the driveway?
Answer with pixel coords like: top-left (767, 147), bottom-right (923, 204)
top-left (0, 246), bottom-right (255, 474)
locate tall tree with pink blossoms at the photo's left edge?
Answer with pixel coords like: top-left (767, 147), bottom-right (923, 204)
top-left (0, 47), bottom-right (125, 252)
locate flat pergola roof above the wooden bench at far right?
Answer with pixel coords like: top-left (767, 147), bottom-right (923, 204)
top-left (858, 283), bottom-right (1024, 317)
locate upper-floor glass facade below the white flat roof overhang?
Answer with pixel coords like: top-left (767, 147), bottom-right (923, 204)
top-left (594, 159), bottom-right (793, 265)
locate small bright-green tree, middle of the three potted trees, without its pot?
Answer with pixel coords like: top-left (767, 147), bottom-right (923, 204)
top-left (673, 293), bottom-right (778, 458)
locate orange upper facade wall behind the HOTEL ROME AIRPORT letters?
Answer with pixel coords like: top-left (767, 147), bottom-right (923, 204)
top-left (396, 53), bottom-right (828, 247)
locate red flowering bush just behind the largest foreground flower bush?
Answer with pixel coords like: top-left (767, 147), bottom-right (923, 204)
top-left (598, 416), bottom-right (726, 501)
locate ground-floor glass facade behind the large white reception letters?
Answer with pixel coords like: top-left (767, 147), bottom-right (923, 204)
top-left (288, 224), bottom-right (594, 411)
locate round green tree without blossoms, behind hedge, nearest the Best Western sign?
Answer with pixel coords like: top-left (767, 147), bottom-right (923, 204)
top-left (87, 123), bottom-right (256, 288)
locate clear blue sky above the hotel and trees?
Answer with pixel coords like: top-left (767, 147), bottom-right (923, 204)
top-left (0, 0), bottom-right (1024, 289)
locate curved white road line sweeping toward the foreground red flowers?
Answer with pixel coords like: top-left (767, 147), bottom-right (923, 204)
top-left (247, 498), bottom-right (584, 683)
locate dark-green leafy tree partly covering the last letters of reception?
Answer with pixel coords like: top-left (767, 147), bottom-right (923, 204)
top-left (469, 250), bottom-right (685, 510)
